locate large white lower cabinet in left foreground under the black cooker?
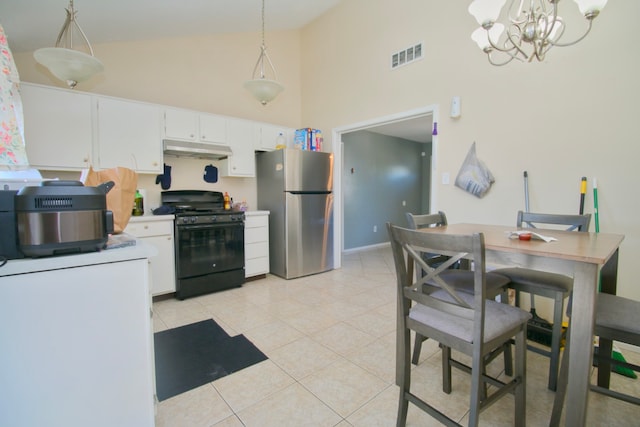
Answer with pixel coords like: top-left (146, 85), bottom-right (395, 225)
top-left (0, 254), bottom-right (155, 427)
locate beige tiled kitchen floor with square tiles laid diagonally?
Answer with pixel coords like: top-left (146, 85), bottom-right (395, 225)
top-left (154, 248), bottom-right (640, 427)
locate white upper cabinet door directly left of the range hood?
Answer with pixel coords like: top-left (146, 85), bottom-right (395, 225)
top-left (97, 98), bottom-right (162, 173)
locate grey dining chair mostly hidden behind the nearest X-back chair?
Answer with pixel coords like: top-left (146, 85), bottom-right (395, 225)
top-left (406, 211), bottom-right (513, 376)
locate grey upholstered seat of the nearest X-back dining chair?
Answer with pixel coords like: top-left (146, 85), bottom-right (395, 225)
top-left (409, 290), bottom-right (531, 343)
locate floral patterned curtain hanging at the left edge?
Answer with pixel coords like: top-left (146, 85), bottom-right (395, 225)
top-left (0, 25), bottom-right (29, 170)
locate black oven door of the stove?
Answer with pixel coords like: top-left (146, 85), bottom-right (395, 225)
top-left (176, 222), bottom-right (244, 279)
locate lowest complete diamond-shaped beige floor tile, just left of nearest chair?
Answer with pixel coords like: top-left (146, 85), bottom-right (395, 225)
top-left (300, 360), bottom-right (387, 417)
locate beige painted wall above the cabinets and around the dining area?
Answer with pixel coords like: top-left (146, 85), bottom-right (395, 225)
top-left (9, 0), bottom-right (640, 299)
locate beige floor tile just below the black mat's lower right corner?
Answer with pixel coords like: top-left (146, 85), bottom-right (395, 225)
top-left (213, 360), bottom-right (295, 413)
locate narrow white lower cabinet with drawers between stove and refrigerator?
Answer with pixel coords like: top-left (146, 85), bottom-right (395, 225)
top-left (244, 211), bottom-right (269, 277)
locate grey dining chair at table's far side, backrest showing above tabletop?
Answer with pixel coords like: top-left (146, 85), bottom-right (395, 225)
top-left (493, 211), bottom-right (591, 391)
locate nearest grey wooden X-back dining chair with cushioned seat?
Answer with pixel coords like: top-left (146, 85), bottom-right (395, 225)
top-left (387, 223), bottom-right (531, 426)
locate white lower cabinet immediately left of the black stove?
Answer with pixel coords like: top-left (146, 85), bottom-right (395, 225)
top-left (124, 216), bottom-right (176, 296)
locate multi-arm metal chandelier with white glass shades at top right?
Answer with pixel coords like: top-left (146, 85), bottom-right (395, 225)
top-left (469, 0), bottom-right (607, 66)
